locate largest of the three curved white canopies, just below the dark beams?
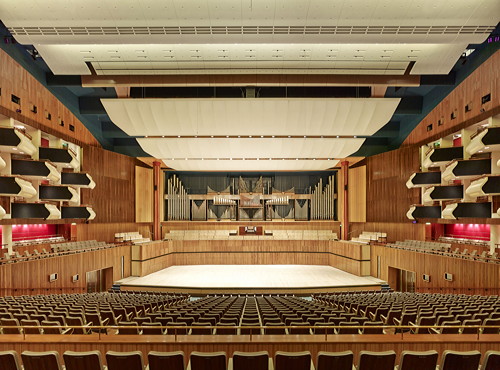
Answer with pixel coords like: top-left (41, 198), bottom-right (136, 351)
top-left (101, 98), bottom-right (400, 136)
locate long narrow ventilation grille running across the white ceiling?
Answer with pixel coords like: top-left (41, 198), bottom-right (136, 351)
top-left (9, 26), bottom-right (495, 36)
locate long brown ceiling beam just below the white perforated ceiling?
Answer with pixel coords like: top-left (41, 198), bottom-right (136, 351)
top-left (81, 74), bottom-right (420, 87)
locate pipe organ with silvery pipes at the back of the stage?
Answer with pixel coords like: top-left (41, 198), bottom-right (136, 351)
top-left (165, 172), bottom-right (337, 221)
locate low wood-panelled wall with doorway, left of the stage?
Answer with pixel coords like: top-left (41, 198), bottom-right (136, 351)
top-left (0, 245), bottom-right (131, 295)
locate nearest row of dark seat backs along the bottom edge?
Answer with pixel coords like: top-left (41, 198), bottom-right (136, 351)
top-left (0, 350), bottom-right (500, 370)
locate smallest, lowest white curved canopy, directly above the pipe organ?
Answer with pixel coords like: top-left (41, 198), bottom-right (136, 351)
top-left (163, 159), bottom-right (338, 171)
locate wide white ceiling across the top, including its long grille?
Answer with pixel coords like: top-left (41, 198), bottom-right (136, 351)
top-left (0, 0), bottom-right (500, 75)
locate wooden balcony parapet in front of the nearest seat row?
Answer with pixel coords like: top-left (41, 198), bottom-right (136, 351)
top-left (0, 334), bottom-right (500, 364)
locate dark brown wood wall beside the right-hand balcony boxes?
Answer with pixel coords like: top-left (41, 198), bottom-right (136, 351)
top-left (366, 147), bottom-right (420, 222)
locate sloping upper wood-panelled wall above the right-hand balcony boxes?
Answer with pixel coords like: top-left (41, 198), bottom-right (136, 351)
top-left (403, 51), bottom-right (500, 145)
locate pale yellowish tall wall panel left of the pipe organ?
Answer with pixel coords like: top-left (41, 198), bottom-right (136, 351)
top-left (135, 166), bottom-right (152, 222)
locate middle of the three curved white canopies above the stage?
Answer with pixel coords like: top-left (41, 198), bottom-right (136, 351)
top-left (137, 138), bottom-right (365, 159)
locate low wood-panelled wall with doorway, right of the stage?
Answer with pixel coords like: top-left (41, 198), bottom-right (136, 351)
top-left (371, 245), bottom-right (500, 294)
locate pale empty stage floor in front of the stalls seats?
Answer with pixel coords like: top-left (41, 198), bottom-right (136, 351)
top-left (117, 265), bottom-right (384, 294)
